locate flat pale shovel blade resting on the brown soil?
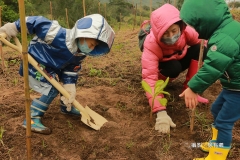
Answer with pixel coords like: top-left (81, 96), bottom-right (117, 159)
top-left (81, 106), bottom-right (108, 130)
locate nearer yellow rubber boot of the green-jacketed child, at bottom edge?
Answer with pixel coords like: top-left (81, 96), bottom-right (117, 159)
top-left (193, 143), bottom-right (230, 160)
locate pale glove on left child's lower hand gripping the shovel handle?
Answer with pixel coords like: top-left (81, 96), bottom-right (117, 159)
top-left (61, 84), bottom-right (76, 112)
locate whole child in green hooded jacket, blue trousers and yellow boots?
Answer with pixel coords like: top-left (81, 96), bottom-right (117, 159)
top-left (180, 0), bottom-right (240, 160)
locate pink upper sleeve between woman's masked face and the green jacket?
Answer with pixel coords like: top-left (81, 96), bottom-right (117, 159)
top-left (184, 26), bottom-right (201, 46)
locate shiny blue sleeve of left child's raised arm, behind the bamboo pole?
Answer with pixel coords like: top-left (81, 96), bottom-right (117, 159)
top-left (15, 16), bottom-right (54, 40)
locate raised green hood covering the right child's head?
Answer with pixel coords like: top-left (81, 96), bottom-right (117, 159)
top-left (180, 0), bottom-right (232, 39)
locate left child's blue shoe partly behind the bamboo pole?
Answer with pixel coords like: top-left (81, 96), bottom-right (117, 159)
top-left (22, 118), bottom-right (52, 134)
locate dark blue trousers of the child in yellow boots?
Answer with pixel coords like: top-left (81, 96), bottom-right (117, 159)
top-left (211, 89), bottom-right (240, 146)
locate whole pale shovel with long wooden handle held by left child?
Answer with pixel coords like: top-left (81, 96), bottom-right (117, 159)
top-left (0, 33), bottom-right (108, 130)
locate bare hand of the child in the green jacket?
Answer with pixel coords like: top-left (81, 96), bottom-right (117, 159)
top-left (179, 88), bottom-right (198, 109)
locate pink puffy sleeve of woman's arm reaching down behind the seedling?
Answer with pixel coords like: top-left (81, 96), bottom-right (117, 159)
top-left (141, 45), bottom-right (166, 112)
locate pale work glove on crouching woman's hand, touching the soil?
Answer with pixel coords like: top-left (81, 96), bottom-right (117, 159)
top-left (155, 111), bottom-right (176, 133)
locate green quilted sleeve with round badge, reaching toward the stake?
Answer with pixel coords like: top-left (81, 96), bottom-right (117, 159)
top-left (188, 34), bottom-right (239, 93)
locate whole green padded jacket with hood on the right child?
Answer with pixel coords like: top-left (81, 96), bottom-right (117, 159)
top-left (180, 0), bottom-right (240, 93)
